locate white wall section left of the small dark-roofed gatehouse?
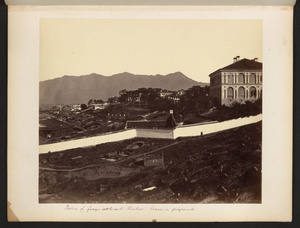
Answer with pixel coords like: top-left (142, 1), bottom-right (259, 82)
top-left (39, 129), bottom-right (136, 154)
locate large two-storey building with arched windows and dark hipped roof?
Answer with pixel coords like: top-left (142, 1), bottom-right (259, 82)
top-left (209, 56), bottom-right (262, 105)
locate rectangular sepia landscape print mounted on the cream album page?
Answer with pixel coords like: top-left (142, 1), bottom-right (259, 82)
top-left (38, 18), bottom-right (264, 204)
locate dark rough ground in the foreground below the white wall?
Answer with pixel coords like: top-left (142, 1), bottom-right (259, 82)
top-left (39, 122), bottom-right (262, 203)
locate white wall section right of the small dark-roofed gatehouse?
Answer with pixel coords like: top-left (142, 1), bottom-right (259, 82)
top-left (174, 114), bottom-right (262, 139)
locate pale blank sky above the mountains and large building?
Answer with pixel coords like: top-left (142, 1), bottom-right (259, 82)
top-left (40, 19), bottom-right (263, 82)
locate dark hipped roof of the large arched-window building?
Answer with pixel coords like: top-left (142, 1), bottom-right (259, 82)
top-left (209, 59), bottom-right (262, 76)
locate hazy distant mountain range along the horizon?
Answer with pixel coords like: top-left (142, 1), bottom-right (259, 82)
top-left (40, 72), bottom-right (208, 105)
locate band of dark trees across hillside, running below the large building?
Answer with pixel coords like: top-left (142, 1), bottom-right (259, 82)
top-left (81, 86), bottom-right (262, 121)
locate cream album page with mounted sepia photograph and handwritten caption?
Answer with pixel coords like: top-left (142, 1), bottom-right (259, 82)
top-left (7, 2), bottom-right (293, 222)
